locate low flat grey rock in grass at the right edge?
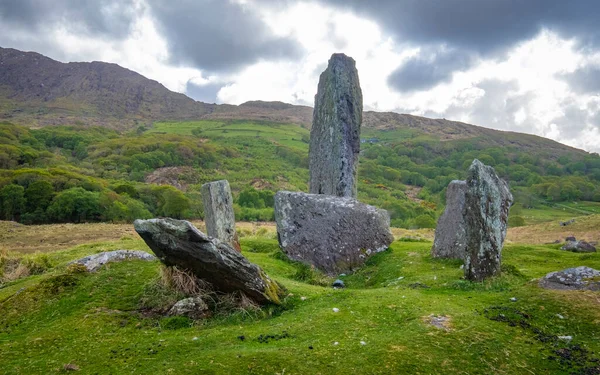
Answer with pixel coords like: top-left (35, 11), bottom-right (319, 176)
top-left (539, 266), bottom-right (600, 291)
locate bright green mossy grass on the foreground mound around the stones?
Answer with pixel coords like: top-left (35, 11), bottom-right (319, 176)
top-left (0, 238), bottom-right (600, 374)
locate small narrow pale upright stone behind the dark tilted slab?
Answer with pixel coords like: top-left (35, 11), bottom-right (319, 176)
top-left (201, 180), bottom-right (242, 251)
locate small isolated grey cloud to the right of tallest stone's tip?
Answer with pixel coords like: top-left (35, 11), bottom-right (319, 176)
top-left (388, 50), bottom-right (473, 92)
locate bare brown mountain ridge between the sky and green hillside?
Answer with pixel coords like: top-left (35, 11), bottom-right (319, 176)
top-left (0, 47), bottom-right (586, 157)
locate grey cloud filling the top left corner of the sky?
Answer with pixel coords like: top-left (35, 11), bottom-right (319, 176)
top-left (0, 0), bottom-right (135, 38)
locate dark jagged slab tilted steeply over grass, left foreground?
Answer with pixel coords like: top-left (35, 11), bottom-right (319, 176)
top-left (133, 218), bottom-right (284, 304)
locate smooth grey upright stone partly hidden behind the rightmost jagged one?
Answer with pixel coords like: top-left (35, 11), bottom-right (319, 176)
top-left (431, 180), bottom-right (467, 259)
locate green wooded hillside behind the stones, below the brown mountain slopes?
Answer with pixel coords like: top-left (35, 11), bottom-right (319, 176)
top-left (0, 120), bottom-right (600, 228)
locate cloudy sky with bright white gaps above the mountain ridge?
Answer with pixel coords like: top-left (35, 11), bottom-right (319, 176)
top-left (0, 0), bottom-right (600, 152)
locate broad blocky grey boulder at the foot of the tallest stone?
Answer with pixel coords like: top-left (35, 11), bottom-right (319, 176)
top-left (275, 191), bottom-right (394, 275)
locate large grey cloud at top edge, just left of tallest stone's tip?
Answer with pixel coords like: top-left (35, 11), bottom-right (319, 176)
top-left (149, 0), bottom-right (302, 72)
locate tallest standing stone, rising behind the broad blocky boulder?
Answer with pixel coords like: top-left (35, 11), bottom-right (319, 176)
top-left (309, 53), bottom-right (363, 198)
